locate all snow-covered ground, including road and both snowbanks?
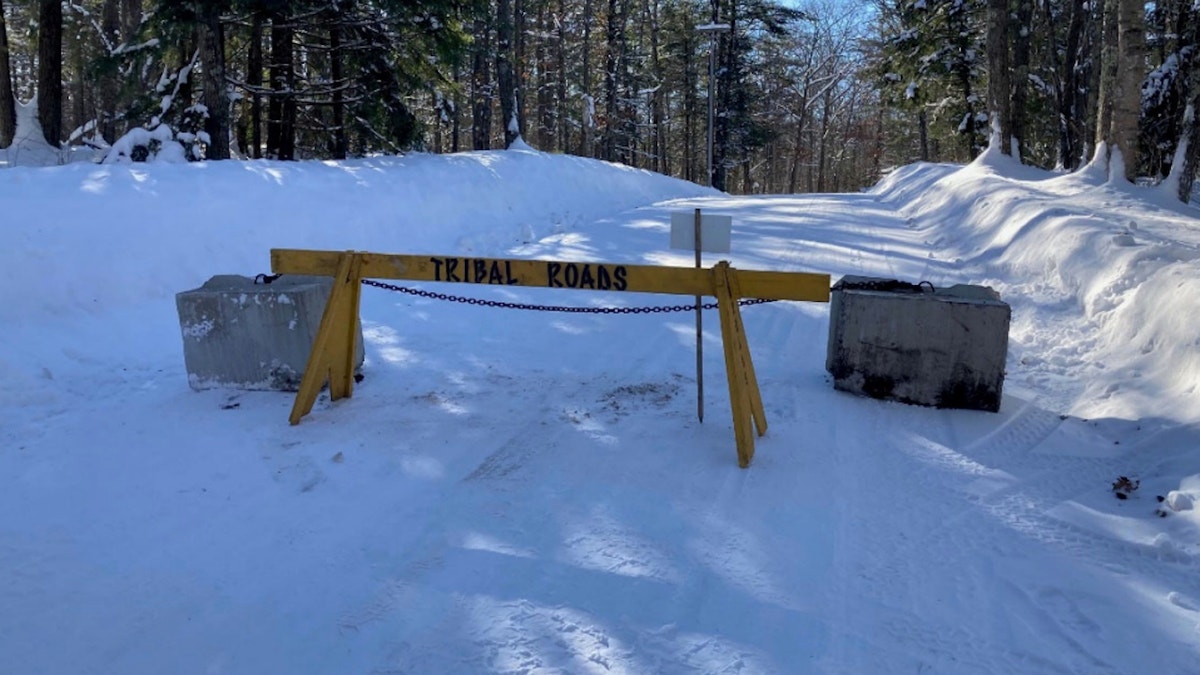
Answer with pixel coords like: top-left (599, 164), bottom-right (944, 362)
top-left (0, 140), bottom-right (1200, 675)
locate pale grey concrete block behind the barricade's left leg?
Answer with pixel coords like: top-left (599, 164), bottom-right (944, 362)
top-left (175, 275), bottom-right (362, 392)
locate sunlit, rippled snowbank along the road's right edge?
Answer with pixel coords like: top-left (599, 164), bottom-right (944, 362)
top-left (875, 154), bottom-right (1200, 420)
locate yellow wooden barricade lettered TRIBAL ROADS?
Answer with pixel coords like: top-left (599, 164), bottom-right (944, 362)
top-left (271, 249), bottom-right (829, 468)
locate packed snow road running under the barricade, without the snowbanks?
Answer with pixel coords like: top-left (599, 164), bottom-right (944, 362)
top-left (0, 154), bottom-right (1200, 675)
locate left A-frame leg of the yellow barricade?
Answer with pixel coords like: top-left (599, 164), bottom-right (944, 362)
top-left (288, 251), bottom-right (362, 424)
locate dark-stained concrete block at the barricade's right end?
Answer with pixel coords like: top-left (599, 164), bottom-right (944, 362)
top-left (826, 276), bottom-right (1012, 412)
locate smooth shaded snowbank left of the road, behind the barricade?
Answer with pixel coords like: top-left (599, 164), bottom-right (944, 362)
top-left (0, 151), bottom-right (714, 321)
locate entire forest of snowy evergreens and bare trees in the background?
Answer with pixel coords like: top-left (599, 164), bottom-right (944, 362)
top-left (0, 0), bottom-right (1200, 198)
